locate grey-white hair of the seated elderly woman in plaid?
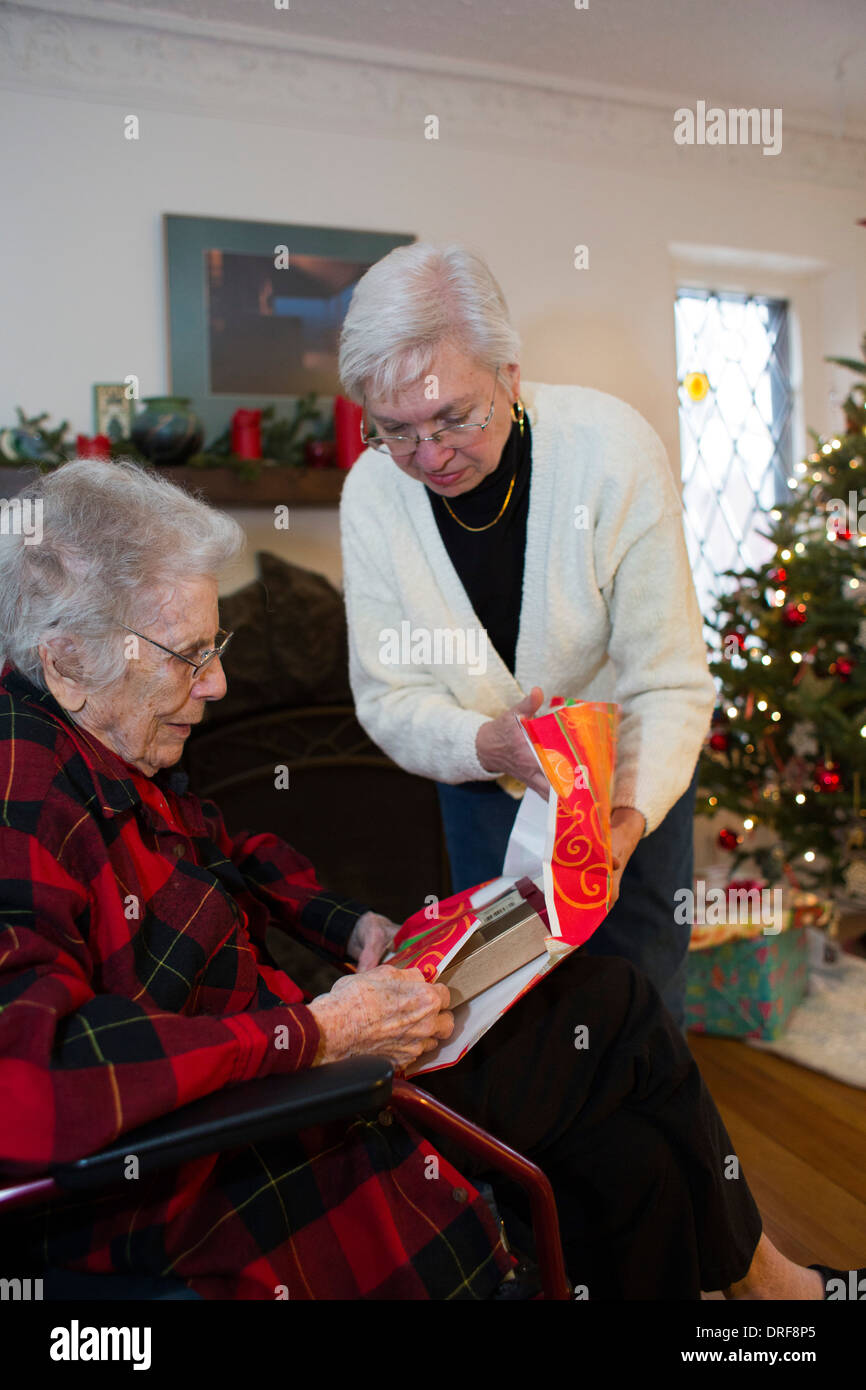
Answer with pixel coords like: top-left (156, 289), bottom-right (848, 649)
top-left (0, 459), bottom-right (246, 691)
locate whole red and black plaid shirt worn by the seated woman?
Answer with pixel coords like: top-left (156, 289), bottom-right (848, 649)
top-left (0, 666), bottom-right (512, 1298)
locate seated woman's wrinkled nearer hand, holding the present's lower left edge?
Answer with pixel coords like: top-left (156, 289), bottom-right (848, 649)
top-left (309, 965), bottom-right (455, 1070)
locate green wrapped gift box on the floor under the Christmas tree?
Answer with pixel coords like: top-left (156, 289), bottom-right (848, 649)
top-left (685, 884), bottom-right (823, 1040)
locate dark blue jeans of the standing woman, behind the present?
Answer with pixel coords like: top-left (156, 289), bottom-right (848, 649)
top-left (436, 767), bottom-right (698, 1030)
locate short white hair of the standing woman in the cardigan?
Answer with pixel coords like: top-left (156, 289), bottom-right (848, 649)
top-left (339, 242), bottom-right (520, 402)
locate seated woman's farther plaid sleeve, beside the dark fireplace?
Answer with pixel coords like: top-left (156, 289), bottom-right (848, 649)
top-left (202, 801), bottom-right (371, 962)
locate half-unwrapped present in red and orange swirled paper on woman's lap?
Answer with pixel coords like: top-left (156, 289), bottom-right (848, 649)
top-left (385, 702), bottom-right (619, 1074)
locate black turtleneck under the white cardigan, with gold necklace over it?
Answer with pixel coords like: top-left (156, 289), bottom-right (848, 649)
top-left (427, 416), bottom-right (532, 674)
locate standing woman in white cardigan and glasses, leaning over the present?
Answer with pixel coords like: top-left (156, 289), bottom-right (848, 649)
top-left (339, 243), bottom-right (714, 1027)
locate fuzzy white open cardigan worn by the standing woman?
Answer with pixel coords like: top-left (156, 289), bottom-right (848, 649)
top-left (341, 382), bottom-right (714, 834)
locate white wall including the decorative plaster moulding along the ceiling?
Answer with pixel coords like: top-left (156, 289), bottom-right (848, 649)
top-left (0, 17), bottom-right (866, 863)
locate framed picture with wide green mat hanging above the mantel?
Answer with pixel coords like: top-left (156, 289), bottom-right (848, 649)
top-left (164, 213), bottom-right (416, 441)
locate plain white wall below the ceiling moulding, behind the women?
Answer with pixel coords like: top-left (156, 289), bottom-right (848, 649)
top-left (0, 73), bottom-right (866, 600)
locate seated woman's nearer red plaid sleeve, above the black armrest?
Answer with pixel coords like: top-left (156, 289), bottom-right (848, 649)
top-left (0, 826), bottom-right (320, 1175)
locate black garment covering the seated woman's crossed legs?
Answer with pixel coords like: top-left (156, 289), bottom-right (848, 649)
top-left (416, 952), bottom-right (762, 1300)
